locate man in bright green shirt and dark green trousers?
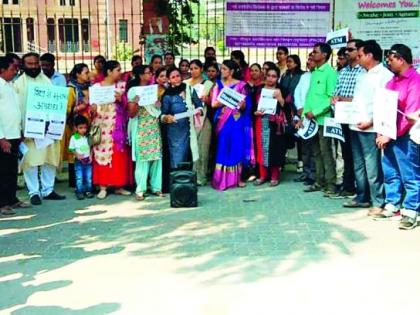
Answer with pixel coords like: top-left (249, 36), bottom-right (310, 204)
top-left (303, 43), bottom-right (337, 197)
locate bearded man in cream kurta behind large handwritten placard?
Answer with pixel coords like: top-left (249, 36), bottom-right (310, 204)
top-left (14, 53), bottom-right (65, 205)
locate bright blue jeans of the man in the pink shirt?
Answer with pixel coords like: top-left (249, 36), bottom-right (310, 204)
top-left (382, 135), bottom-right (420, 213)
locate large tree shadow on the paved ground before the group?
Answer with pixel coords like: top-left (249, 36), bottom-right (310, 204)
top-left (0, 169), bottom-right (365, 314)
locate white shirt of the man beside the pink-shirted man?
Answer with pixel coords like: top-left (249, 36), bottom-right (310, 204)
top-left (350, 63), bottom-right (394, 132)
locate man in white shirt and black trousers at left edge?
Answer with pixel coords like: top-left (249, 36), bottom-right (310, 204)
top-left (0, 56), bottom-right (29, 215)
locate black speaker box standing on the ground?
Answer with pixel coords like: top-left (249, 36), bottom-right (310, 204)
top-left (170, 170), bottom-right (198, 208)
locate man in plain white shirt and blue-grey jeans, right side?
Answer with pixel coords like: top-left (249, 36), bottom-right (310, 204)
top-left (340, 40), bottom-right (392, 215)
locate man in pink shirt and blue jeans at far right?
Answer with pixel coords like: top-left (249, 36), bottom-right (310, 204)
top-left (375, 44), bottom-right (420, 230)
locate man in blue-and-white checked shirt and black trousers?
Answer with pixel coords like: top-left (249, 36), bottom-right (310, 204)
top-left (330, 39), bottom-right (366, 198)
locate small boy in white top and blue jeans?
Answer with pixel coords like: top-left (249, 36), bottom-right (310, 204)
top-left (69, 116), bottom-right (93, 200)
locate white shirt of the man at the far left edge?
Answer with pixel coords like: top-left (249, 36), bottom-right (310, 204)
top-left (0, 78), bottom-right (22, 139)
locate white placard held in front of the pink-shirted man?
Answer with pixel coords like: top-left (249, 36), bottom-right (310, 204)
top-left (373, 89), bottom-right (398, 140)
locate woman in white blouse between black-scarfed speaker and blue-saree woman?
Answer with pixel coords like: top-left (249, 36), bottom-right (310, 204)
top-left (185, 59), bottom-right (214, 185)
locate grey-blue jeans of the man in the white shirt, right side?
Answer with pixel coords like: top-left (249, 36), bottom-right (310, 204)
top-left (351, 130), bottom-right (384, 207)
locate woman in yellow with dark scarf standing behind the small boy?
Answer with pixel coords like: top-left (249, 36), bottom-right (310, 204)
top-left (61, 63), bottom-right (91, 187)
